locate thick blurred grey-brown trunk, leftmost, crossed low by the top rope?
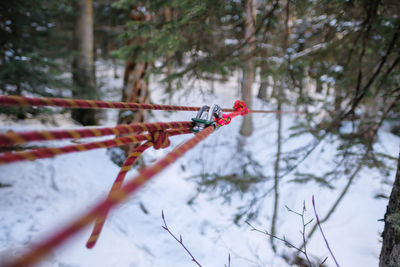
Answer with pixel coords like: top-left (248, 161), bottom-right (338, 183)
top-left (71, 0), bottom-right (97, 125)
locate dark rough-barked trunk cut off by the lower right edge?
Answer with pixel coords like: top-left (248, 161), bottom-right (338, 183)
top-left (379, 155), bottom-right (400, 267)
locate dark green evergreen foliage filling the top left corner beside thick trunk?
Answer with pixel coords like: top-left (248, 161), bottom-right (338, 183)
top-left (0, 0), bottom-right (67, 118)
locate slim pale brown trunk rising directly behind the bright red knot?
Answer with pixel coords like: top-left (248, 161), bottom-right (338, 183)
top-left (240, 0), bottom-right (257, 136)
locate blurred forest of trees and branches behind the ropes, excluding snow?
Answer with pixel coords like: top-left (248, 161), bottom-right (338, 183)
top-left (0, 0), bottom-right (400, 266)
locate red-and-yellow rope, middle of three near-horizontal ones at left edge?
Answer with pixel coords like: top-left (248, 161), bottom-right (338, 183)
top-left (0, 121), bottom-right (193, 146)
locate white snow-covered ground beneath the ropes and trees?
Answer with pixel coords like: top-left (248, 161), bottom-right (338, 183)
top-left (0, 61), bottom-right (399, 267)
